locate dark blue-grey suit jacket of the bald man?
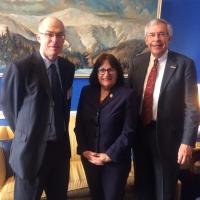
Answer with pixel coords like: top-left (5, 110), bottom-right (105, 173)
top-left (1, 52), bottom-right (74, 179)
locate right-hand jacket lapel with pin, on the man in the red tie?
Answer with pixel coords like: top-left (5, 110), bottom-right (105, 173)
top-left (160, 52), bottom-right (178, 94)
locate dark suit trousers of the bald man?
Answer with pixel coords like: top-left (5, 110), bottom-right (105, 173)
top-left (14, 142), bottom-right (70, 200)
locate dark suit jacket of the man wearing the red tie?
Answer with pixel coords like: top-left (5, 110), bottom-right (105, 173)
top-left (128, 51), bottom-right (199, 162)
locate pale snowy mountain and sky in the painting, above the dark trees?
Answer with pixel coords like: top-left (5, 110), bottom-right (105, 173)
top-left (0, 0), bottom-right (157, 67)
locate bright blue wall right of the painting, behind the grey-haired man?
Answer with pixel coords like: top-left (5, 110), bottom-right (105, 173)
top-left (161, 0), bottom-right (200, 83)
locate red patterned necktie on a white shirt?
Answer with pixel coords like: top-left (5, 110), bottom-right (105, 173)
top-left (141, 59), bottom-right (158, 126)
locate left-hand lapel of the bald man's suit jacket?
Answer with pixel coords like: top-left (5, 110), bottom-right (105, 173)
top-left (34, 52), bottom-right (51, 97)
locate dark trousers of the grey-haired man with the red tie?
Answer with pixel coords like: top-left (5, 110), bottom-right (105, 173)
top-left (134, 122), bottom-right (178, 200)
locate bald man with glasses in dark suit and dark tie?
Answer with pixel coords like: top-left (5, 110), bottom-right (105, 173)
top-left (1, 17), bottom-right (74, 200)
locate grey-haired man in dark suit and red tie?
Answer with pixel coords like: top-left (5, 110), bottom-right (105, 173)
top-left (128, 19), bottom-right (199, 200)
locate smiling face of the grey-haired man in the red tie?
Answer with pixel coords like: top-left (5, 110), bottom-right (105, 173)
top-left (145, 23), bottom-right (171, 58)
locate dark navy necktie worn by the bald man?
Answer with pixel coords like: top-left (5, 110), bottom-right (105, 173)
top-left (48, 64), bottom-right (64, 138)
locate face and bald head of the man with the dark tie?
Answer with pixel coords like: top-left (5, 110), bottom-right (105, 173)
top-left (36, 17), bottom-right (64, 61)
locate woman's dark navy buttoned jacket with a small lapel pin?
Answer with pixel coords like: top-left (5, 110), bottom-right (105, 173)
top-left (75, 86), bottom-right (137, 162)
